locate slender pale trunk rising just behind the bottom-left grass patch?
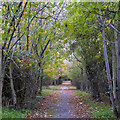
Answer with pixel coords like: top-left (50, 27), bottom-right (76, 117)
top-left (9, 61), bottom-right (17, 106)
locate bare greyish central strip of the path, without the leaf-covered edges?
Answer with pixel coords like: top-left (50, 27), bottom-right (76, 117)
top-left (49, 82), bottom-right (78, 118)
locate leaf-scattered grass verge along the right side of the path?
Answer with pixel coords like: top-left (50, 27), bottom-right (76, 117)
top-left (75, 91), bottom-right (116, 118)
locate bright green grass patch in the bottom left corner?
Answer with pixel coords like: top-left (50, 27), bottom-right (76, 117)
top-left (2, 107), bottom-right (30, 118)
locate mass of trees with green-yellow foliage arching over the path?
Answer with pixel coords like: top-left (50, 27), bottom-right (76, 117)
top-left (0, 1), bottom-right (120, 117)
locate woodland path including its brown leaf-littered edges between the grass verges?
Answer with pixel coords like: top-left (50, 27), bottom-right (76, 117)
top-left (27, 81), bottom-right (92, 118)
